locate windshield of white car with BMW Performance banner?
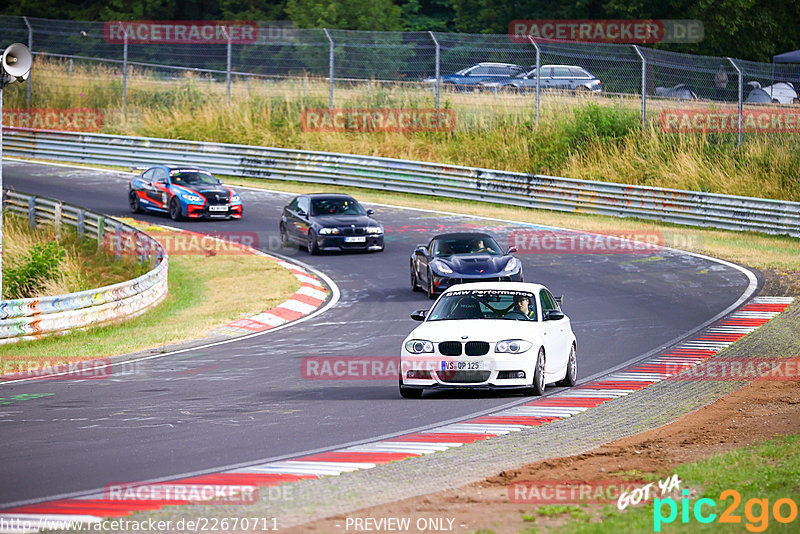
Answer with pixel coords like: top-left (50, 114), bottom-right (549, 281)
top-left (427, 289), bottom-right (538, 321)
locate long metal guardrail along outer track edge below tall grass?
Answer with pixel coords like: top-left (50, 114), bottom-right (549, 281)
top-left (3, 128), bottom-right (800, 236)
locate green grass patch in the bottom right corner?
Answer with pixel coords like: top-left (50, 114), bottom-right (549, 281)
top-left (555, 434), bottom-right (800, 534)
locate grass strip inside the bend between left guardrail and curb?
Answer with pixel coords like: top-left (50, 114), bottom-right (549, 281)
top-left (0, 220), bottom-right (300, 363)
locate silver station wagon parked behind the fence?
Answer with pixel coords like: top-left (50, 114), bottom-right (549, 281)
top-left (478, 65), bottom-right (603, 92)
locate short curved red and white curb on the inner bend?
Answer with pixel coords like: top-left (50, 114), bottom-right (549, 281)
top-left (212, 258), bottom-right (328, 336)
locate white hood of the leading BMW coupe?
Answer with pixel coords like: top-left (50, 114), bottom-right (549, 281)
top-left (409, 319), bottom-right (544, 343)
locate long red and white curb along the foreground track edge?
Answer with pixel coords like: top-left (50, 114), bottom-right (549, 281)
top-left (0, 298), bottom-right (794, 532)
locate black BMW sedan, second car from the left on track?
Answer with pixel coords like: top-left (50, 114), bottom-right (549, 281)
top-left (280, 193), bottom-right (384, 254)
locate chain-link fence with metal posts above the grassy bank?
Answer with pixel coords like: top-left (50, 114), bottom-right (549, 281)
top-left (0, 16), bottom-right (800, 142)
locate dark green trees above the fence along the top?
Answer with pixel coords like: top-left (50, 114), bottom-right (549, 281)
top-left (0, 0), bottom-right (800, 61)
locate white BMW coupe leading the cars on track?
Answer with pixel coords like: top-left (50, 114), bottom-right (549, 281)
top-left (400, 282), bottom-right (578, 398)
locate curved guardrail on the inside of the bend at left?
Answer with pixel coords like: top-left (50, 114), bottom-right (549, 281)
top-left (0, 191), bottom-right (168, 343)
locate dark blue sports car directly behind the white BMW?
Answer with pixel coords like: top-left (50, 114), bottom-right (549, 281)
top-left (411, 232), bottom-right (522, 298)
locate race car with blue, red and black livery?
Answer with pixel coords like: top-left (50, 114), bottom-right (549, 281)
top-left (128, 165), bottom-right (242, 221)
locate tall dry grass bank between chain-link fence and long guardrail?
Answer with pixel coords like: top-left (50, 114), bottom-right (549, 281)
top-left (7, 59), bottom-right (800, 201)
